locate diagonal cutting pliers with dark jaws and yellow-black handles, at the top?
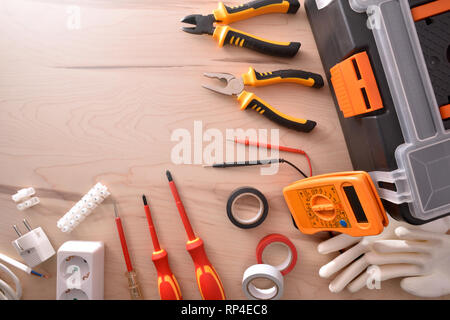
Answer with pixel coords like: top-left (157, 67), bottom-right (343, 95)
top-left (181, 0), bottom-right (300, 57)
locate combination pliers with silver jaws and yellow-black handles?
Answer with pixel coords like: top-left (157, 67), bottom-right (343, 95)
top-left (203, 67), bottom-right (323, 132)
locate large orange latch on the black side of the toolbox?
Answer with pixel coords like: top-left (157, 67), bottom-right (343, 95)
top-left (330, 52), bottom-right (383, 118)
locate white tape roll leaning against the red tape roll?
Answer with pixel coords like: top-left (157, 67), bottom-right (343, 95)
top-left (242, 264), bottom-right (284, 300)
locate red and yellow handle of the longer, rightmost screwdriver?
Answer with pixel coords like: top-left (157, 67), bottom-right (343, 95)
top-left (186, 238), bottom-right (226, 300)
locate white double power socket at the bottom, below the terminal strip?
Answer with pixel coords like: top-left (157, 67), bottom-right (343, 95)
top-left (56, 241), bottom-right (105, 300)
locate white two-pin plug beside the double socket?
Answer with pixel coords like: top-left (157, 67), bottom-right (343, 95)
top-left (11, 219), bottom-right (55, 268)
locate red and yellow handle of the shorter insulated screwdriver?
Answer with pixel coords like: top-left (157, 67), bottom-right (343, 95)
top-left (152, 249), bottom-right (183, 300)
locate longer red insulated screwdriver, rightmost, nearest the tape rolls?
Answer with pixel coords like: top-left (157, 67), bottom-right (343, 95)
top-left (166, 170), bottom-right (226, 300)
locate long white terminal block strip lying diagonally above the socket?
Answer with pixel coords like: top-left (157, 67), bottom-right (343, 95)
top-left (56, 182), bottom-right (110, 232)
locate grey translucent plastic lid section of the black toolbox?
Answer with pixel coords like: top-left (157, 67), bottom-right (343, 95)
top-left (356, 0), bottom-right (450, 223)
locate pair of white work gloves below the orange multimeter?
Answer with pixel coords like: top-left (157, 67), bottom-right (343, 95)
top-left (317, 216), bottom-right (450, 298)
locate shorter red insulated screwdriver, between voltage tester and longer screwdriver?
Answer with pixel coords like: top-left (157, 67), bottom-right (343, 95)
top-left (142, 195), bottom-right (183, 300)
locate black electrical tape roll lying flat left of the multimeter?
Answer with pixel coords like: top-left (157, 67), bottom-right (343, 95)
top-left (227, 187), bottom-right (269, 229)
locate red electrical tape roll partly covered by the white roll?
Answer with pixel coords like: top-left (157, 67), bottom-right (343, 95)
top-left (256, 233), bottom-right (297, 276)
